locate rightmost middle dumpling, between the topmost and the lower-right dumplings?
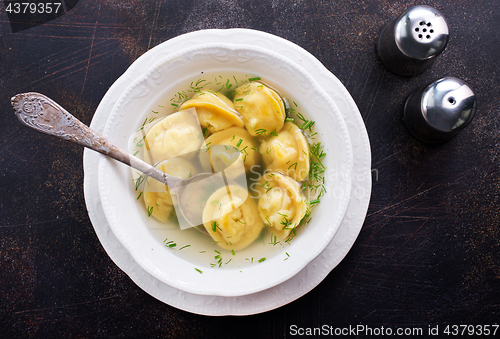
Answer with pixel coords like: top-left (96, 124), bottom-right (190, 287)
top-left (260, 122), bottom-right (309, 181)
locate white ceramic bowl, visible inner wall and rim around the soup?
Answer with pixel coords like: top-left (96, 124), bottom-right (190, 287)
top-left (98, 44), bottom-right (353, 296)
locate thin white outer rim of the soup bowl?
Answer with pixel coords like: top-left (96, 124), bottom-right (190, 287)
top-left (98, 43), bottom-right (353, 297)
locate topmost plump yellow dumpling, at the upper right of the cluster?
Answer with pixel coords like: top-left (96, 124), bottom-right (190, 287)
top-left (234, 82), bottom-right (285, 137)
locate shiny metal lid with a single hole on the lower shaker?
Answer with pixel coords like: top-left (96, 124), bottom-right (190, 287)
top-left (421, 77), bottom-right (476, 132)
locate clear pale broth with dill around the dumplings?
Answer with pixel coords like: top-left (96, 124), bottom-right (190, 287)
top-left (129, 71), bottom-right (319, 270)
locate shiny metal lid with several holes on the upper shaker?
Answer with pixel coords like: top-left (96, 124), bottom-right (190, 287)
top-left (394, 6), bottom-right (449, 60)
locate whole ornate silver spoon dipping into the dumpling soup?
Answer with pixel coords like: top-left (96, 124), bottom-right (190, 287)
top-left (11, 92), bottom-right (225, 226)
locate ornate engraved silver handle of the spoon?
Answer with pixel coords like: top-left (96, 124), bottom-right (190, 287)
top-left (11, 92), bottom-right (182, 190)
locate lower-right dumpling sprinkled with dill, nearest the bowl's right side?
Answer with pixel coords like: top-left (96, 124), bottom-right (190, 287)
top-left (255, 172), bottom-right (308, 239)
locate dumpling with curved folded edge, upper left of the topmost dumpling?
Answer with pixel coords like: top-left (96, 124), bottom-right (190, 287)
top-left (180, 91), bottom-right (244, 134)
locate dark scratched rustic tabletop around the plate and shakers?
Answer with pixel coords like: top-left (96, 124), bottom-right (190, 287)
top-left (0, 0), bottom-right (500, 338)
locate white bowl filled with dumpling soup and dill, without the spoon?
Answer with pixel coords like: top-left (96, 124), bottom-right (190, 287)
top-left (98, 44), bottom-right (353, 296)
